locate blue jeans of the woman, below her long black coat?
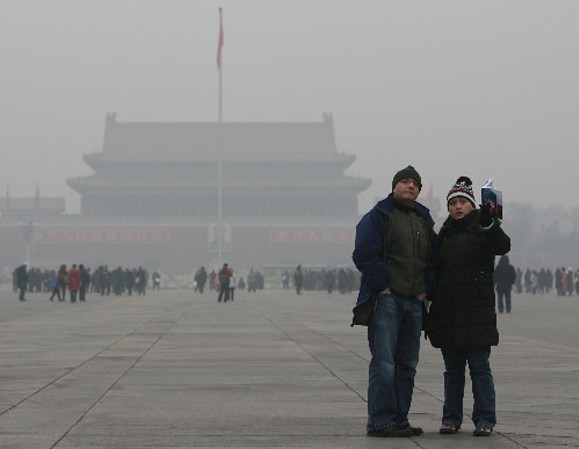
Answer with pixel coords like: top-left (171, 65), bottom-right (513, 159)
top-left (442, 346), bottom-right (497, 427)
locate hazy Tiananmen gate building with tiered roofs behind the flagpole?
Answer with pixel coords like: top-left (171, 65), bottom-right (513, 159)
top-left (0, 114), bottom-right (370, 274)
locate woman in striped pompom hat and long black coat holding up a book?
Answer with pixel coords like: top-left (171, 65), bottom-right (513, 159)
top-left (428, 176), bottom-right (511, 436)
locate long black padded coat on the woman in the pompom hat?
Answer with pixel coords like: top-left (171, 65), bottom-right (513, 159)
top-left (427, 211), bottom-right (511, 348)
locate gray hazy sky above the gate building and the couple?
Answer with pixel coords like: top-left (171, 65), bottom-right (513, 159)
top-left (0, 0), bottom-right (579, 213)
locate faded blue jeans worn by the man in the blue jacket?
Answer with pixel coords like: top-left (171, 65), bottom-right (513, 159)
top-left (367, 294), bottom-right (422, 431)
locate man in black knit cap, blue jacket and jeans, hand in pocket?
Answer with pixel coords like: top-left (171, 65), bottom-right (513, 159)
top-left (352, 165), bottom-right (436, 437)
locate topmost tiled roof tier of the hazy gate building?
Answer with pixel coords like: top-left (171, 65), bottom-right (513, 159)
top-left (92, 115), bottom-right (344, 161)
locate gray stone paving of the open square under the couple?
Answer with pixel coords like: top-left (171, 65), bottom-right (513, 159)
top-left (0, 288), bottom-right (579, 449)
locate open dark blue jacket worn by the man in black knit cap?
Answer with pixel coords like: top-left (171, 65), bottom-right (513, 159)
top-left (352, 194), bottom-right (436, 326)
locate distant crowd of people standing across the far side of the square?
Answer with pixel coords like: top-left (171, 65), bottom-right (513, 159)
top-left (13, 256), bottom-right (579, 306)
